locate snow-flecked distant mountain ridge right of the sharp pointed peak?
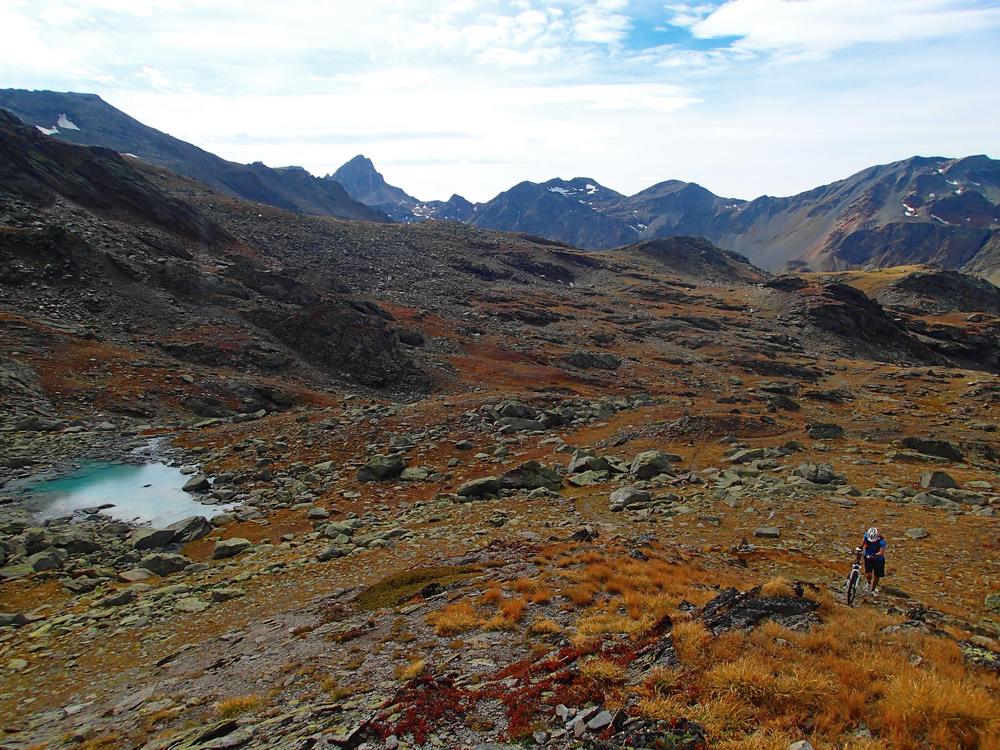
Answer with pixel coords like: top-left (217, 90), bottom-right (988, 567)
top-left (332, 155), bottom-right (1000, 281)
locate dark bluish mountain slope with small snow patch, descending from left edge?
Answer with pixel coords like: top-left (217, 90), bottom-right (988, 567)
top-left (0, 89), bottom-right (387, 221)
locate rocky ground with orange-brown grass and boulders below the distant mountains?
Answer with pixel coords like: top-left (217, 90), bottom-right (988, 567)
top-left (0, 107), bottom-right (1000, 750)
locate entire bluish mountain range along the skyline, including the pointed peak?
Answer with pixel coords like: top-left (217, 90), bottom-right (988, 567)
top-left (0, 89), bottom-right (1000, 281)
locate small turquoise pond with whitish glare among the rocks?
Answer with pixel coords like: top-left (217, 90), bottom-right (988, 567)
top-left (22, 462), bottom-right (228, 527)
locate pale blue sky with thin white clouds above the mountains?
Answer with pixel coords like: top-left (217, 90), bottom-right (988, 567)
top-left (0, 0), bottom-right (1000, 201)
